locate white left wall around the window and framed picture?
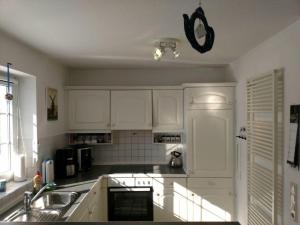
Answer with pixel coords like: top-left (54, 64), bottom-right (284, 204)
top-left (0, 31), bottom-right (68, 174)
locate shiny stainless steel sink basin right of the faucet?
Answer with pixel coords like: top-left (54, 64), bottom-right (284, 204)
top-left (31, 191), bottom-right (79, 210)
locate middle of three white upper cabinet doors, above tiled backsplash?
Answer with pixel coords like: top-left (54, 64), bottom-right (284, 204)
top-left (111, 90), bottom-right (152, 130)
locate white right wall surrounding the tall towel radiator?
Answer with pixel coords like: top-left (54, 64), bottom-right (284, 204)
top-left (227, 20), bottom-right (300, 225)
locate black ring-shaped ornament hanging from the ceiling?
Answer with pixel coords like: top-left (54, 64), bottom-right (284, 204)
top-left (183, 7), bottom-right (215, 53)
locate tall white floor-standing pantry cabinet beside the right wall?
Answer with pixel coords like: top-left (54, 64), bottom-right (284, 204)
top-left (184, 83), bottom-right (234, 221)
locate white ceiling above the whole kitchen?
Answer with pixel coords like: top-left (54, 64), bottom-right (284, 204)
top-left (0, 0), bottom-right (300, 68)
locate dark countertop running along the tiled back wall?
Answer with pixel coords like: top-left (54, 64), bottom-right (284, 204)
top-left (55, 165), bottom-right (186, 185)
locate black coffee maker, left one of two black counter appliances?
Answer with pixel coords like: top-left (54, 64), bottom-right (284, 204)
top-left (54, 147), bottom-right (78, 179)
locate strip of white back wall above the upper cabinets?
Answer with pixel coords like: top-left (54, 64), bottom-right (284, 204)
top-left (67, 67), bottom-right (225, 85)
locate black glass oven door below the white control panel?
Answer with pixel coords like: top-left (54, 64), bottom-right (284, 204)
top-left (108, 187), bottom-right (153, 221)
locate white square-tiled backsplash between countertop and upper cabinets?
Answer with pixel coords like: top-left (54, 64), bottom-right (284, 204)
top-left (93, 131), bottom-right (182, 165)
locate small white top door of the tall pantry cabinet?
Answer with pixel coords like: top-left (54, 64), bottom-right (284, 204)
top-left (184, 87), bottom-right (234, 109)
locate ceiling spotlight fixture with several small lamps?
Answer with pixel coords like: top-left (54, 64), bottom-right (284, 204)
top-left (153, 38), bottom-right (180, 60)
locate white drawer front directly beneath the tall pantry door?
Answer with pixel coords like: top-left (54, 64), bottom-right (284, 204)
top-left (187, 178), bottom-right (233, 189)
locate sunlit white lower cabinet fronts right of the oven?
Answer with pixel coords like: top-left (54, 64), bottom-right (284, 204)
top-left (153, 178), bottom-right (235, 222)
